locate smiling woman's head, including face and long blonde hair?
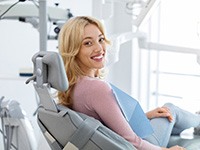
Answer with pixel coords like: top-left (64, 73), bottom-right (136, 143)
top-left (58, 17), bottom-right (110, 107)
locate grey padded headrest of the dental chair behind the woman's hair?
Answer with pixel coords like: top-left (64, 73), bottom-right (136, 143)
top-left (32, 51), bottom-right (68, 91)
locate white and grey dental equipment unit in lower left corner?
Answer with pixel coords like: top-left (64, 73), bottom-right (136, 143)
top-left (0, 97), bottom-right (37, 150)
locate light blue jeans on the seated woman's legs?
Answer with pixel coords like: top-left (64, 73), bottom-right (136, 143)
top-left (144, 103), bottom-right (200, 147)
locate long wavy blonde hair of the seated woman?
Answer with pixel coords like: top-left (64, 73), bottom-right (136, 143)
top-left (58, 16), bottom-right (110, 108)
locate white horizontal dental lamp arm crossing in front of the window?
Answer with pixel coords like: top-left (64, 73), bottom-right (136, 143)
top-left (108, 31), bottom-right (200, 65)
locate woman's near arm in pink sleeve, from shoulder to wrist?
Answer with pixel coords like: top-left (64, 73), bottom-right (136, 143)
top-left (85, 81), bottom-right (161, 150)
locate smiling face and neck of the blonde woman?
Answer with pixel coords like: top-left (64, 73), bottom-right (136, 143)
top-left (77, 24), bottom-right (106, 77)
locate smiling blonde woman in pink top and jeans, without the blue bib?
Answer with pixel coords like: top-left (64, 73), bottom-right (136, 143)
top-left (58, 16), bottom-right (200, 150)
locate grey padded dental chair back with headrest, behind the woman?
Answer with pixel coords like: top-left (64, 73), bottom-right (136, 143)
top-left (30, 51), bottom-right (135, 150)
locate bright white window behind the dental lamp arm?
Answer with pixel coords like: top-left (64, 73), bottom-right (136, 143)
top-left (140, 0), bottom-right (200, 112)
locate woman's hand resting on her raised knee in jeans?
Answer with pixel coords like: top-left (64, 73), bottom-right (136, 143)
top-left (146, 107), bottom-right (173, 122)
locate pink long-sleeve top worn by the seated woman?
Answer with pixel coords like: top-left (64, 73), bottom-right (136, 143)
top-left (72, 77), bottom-right (161, 150)
